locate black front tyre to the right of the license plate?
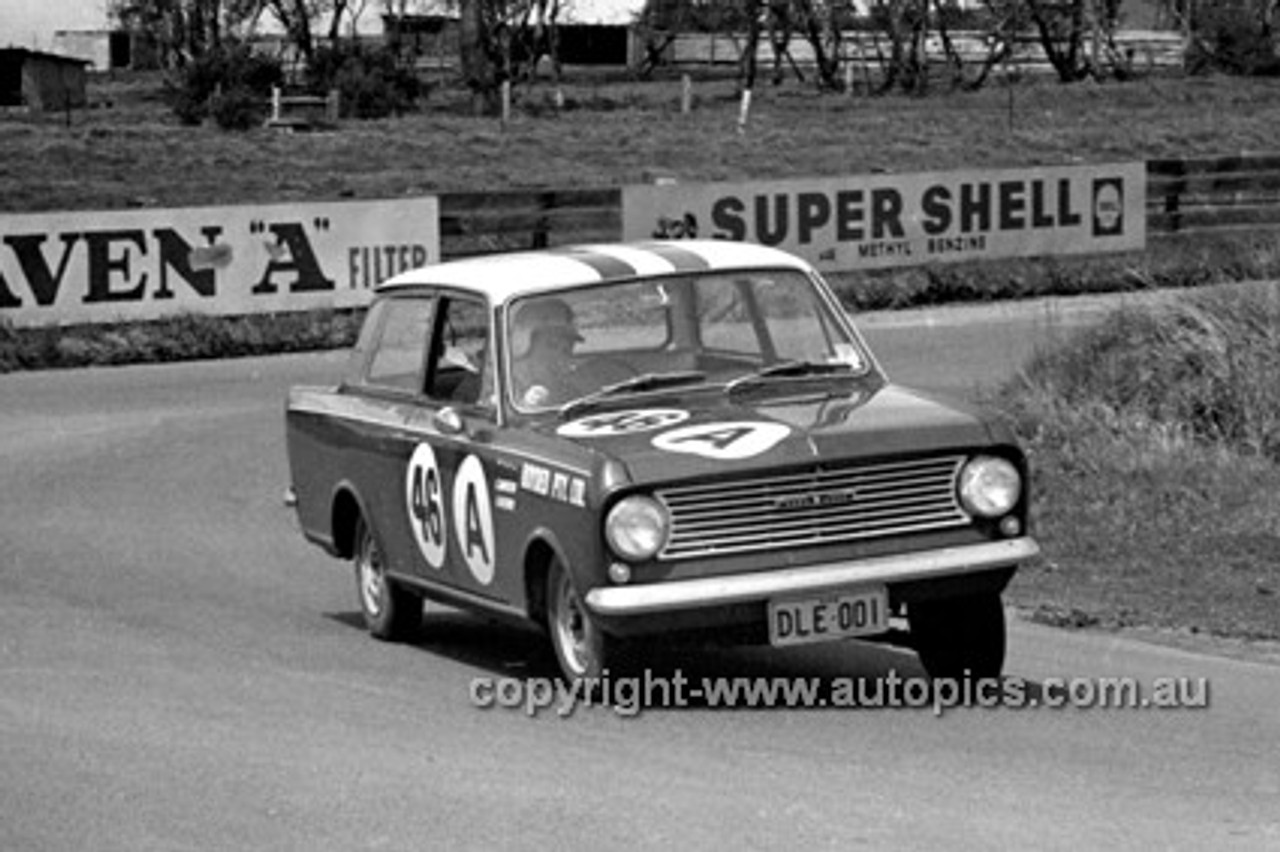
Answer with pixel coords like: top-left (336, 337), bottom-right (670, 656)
top-left (908, 592), bottom-right (1005, 679)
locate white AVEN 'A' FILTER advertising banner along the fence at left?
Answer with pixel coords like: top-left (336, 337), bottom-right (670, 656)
top-left (0, 197), bottom-right (440, 326)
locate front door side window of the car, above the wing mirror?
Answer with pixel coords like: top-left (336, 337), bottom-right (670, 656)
top-left (426, 297), bottom-right (494, 407)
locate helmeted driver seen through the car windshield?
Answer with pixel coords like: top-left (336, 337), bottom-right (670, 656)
top-left (511, 298), bottom-right (582, 407)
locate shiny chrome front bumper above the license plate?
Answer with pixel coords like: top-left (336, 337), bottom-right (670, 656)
top-left (586, 536), bottom-right (1039, 615)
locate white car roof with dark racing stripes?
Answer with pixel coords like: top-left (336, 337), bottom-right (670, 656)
top-left (378, 239), bottom-right (810, 304)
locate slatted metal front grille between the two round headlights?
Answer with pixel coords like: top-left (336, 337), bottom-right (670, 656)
top-left (657, 455), bottom-right (970, 559)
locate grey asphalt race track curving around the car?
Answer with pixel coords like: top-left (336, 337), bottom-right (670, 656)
top-left (0, 294), bottom-right (1280, 852)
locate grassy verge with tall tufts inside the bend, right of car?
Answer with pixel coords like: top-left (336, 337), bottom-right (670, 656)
top-left (991, 285), bottom-right (1280, 640)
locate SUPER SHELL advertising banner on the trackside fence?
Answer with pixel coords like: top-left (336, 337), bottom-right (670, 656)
top-left (622, 162), bottom-right (1147, 270)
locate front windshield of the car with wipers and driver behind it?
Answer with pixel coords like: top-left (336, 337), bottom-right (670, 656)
top-left (507, 270), bottom-right (869, 412)
